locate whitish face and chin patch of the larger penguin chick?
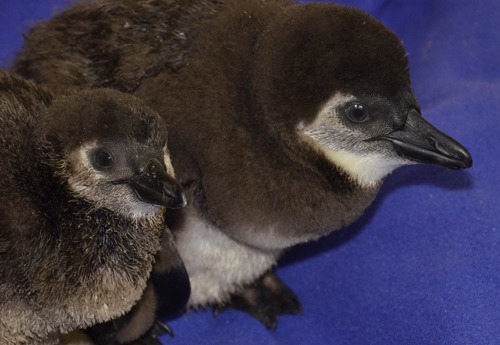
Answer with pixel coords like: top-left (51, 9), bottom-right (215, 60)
top-left (298, 94), bottom-right (408, 187)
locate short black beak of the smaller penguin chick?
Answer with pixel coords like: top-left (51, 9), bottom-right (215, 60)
top-left (127, 159), bottom-right (187, 208)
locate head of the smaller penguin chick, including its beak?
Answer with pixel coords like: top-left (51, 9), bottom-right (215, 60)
top-left (36, 89), bottom-right (186, 218)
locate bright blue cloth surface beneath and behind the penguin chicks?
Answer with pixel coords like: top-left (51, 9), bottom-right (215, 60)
top-left (0, 0), bottom-right (500, 345)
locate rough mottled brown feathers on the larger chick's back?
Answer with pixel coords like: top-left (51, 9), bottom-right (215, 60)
top-left (14, 0), bottom-right (222, 92)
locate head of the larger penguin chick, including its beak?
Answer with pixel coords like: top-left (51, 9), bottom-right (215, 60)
top-left (252, 4), bottom-right (472, 186)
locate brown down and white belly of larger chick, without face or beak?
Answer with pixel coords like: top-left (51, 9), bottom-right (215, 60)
top-left (11, 0), bottom-right (440, 325)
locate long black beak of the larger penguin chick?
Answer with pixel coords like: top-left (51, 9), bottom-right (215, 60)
top-left (374, 109), bottom-right (472, 169)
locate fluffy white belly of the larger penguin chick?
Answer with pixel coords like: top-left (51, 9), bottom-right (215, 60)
top-left (176, 207), bottom-right (281, 307)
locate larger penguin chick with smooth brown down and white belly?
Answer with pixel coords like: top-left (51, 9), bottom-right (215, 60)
top-left (12, 0), bottom-right (472, 328)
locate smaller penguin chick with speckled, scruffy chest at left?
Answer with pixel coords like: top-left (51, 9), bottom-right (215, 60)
top-left (0, 71), bottom-right (185, 344)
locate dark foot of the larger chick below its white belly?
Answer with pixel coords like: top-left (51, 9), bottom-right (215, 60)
top-left (212, 271), bottom-right (302, 330)
